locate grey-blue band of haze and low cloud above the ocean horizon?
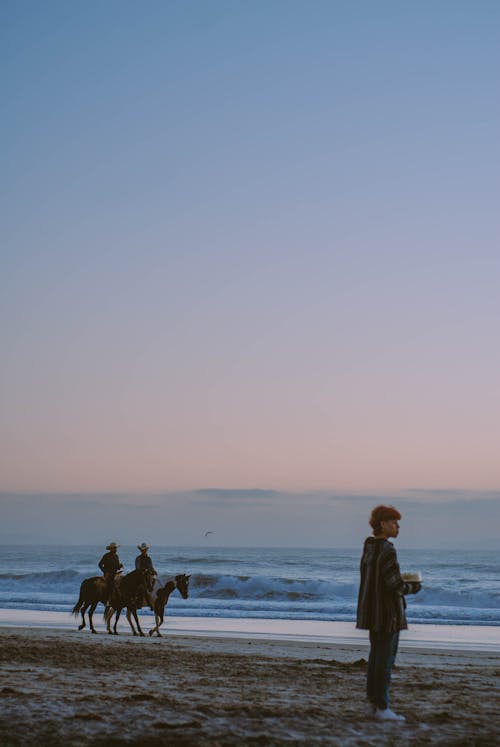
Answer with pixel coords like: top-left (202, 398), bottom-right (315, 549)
top-left (0, 489), bottom-right (500, 549)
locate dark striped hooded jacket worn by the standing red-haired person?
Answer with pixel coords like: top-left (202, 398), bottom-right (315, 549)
top-left (356, 537), bottom-right (413, 633)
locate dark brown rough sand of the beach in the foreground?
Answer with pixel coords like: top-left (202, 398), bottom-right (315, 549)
top-left (0, 622), bottom-right (500, 747)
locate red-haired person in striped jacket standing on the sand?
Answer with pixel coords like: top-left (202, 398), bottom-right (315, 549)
top-left (356, 506), bottom-right (421, 721)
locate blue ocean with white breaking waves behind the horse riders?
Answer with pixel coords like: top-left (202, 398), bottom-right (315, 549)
top-left (0, 545), bottom-right (500, 625)
